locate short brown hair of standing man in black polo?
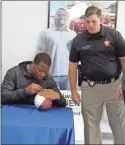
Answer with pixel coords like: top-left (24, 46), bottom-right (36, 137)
top-left (85, 6), bottom-right (101, 17)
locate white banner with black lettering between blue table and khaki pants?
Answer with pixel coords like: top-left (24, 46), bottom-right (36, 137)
top-left (61, 90), bottom-right (84, 142)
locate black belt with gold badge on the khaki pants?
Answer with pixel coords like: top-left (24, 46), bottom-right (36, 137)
top-left (83, 77), bottom-right (119, 87)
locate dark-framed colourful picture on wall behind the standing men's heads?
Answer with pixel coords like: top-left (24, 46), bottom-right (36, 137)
top-left (48, 1), bottom-right (117, 33)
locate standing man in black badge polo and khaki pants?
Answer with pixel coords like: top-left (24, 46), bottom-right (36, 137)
top-left (69, 6), bottom-right (125, 144)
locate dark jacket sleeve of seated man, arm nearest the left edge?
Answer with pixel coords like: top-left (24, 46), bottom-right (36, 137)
top-left (1, 69), bottom-right (27, 104)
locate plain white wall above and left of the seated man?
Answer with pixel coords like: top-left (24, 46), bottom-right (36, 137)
top-left (2, 1), bottom-right (48, 78)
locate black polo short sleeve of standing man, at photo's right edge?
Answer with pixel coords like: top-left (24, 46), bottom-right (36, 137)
top-left (115, 31), bottom-right (125, 57)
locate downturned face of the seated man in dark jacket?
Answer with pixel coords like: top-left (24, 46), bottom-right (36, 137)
top-left (33, 62), bottom-right (49, 80)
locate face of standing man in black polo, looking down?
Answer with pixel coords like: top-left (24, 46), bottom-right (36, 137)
top-left (85, 14), bottom-right (101, 34)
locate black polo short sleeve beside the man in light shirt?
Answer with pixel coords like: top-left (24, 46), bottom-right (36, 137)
top-left (69, 40), bottom-right (80, 63)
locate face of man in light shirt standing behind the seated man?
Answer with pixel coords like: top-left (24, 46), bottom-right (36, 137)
top-left (55, 10), bottom-right (67, 26)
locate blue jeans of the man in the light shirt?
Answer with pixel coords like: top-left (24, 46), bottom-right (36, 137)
top-left (53, 76), bottom-right (70, 90)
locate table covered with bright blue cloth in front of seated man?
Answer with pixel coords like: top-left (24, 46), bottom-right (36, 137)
top-left (1, 105), bottom-right (75, 144)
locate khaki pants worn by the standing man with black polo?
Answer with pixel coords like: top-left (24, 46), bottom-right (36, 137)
top-left (81, 81), bottom-right (125, 144)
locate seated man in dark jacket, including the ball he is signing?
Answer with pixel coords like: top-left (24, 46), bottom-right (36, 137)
top-left (1, 53), bottom-right (66, 109)
